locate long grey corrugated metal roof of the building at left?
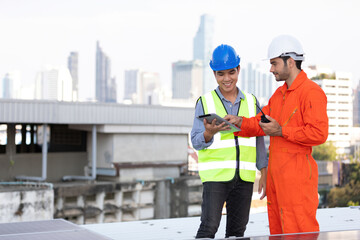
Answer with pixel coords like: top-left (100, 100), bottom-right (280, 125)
top-left (0, 99), bottom-right (194, 127)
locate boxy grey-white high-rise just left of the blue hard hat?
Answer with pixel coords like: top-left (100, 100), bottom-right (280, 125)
top-left (172, 60), bottom-right (202, 101)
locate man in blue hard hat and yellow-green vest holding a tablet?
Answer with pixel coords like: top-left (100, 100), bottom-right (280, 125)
top-left (191, 44), bottom-right (267, 238)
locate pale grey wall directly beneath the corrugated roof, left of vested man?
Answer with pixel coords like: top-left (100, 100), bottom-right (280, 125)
top-left (87, 133), bottom-right (188, 168)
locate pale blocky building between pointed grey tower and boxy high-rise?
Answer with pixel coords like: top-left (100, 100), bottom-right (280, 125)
top-left (124, 69), bottom-right (160, 105)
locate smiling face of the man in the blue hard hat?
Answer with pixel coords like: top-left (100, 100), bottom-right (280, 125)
top-left (214, 67), bottom-right (240, 93)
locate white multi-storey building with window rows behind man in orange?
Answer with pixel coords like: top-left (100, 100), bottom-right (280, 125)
top-left (305, 66), bottom-right (353, 154)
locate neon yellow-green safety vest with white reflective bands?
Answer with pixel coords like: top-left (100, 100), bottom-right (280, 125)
top-left (198, 90), bottom-right (256, 182)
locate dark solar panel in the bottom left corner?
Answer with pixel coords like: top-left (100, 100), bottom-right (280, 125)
top-left (0, 219), bottom-right (110, 240)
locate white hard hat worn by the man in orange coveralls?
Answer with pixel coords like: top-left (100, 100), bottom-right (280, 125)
top-left (268, 35), bottom-right (305, 61)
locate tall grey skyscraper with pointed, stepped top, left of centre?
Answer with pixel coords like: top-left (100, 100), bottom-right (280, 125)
top-left (95, 42), bottom-right (116, 102)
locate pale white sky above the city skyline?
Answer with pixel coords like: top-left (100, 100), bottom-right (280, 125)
top-left (0, 0), bottom-right (360, 99)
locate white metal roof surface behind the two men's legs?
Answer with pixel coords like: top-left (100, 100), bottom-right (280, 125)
top-left (82, 207), bottom-right (360, 240)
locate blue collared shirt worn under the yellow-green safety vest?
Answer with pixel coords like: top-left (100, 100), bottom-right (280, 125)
top-left (191, 87), bottom-right (268, 170)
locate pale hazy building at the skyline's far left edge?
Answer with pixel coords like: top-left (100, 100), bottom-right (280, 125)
top-left (2, 71), bottom-right (21, 99)
